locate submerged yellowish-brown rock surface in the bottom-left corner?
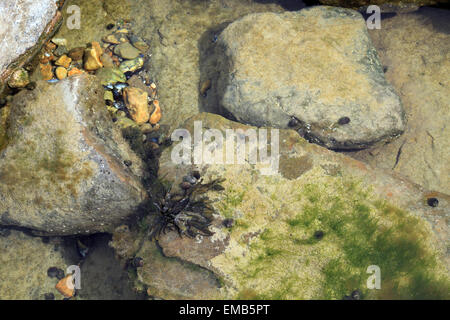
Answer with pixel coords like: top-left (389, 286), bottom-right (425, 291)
top-left (0, 230), bottom-right (67, 300)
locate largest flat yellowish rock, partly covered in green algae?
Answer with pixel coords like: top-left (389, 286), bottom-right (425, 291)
top-left (136, 113), bottom-right (450, 299)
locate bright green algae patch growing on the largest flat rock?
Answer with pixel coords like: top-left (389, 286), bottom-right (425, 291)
top-left (225, 179), bottom-right (450, 299)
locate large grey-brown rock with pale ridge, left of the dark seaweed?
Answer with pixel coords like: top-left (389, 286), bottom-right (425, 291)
top-left (0, 75), bottom-right (146, 234)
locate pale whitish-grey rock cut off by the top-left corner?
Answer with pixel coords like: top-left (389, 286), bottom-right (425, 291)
top-left (0, 0), bottom-right (61, 91)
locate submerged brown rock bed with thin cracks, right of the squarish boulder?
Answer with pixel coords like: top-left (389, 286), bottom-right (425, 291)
top-left (349, 8), bottom-right (450, 194)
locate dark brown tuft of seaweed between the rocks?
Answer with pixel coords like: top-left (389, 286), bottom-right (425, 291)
top-left (149, 175), bottom-right (224, 239)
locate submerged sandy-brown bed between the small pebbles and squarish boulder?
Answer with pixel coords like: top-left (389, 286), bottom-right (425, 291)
top-left (132, 0), bottom-right (285, 131)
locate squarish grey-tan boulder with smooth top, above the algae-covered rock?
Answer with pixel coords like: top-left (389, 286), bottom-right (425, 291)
top-left (216, 6), bottom-right (405, 149)
